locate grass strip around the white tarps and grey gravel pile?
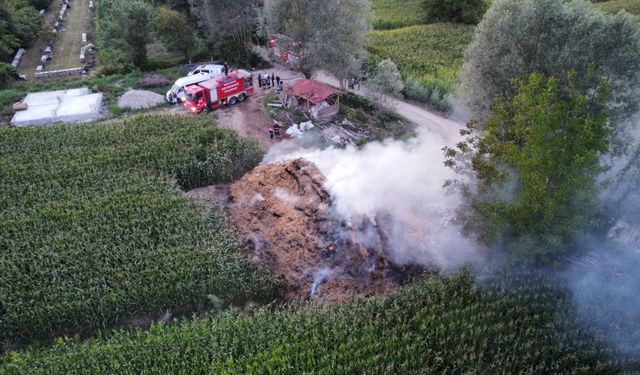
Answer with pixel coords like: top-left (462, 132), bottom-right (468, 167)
top-left (0, 68), bottom-right (184, 127)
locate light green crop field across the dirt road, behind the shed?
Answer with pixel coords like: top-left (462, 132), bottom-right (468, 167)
top-left (369, 23), bottom-right (473, 106)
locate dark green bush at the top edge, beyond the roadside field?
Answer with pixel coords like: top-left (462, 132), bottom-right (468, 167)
top-left (422, 0), bottom-right (487, 24)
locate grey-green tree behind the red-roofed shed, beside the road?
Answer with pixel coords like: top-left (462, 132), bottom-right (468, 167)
top-left (260, 0), bottom-right (371, 87)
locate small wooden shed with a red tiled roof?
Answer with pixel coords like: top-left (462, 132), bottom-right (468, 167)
top-left (285, 79), bottom-right (342, 122)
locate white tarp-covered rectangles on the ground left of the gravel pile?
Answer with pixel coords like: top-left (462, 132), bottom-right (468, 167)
top-left (11, 87), bottom-right (103, 127)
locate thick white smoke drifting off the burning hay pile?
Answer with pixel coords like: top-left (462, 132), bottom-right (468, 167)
top-left (268, 132), bottom-right (480, 269)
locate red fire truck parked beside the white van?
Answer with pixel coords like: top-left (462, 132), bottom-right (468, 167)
top-left (184, 70), bottom-right (254, 113)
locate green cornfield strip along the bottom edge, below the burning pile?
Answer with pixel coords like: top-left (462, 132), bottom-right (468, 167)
top-left (0, 275), bottom-right (640, 374)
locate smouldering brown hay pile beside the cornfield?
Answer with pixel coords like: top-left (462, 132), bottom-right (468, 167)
top-left (230, 159), bottom-right (418, 301)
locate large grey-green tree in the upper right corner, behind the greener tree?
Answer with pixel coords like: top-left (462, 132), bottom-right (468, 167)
top-left (459, 0), bottom-right (640, 135)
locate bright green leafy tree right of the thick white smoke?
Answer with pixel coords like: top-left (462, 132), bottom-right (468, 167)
top-left (445, 74), bottom-right (610, 258)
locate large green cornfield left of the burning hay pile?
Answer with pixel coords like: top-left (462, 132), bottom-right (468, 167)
top-left (0, 116), bottom-right (276, 351)
